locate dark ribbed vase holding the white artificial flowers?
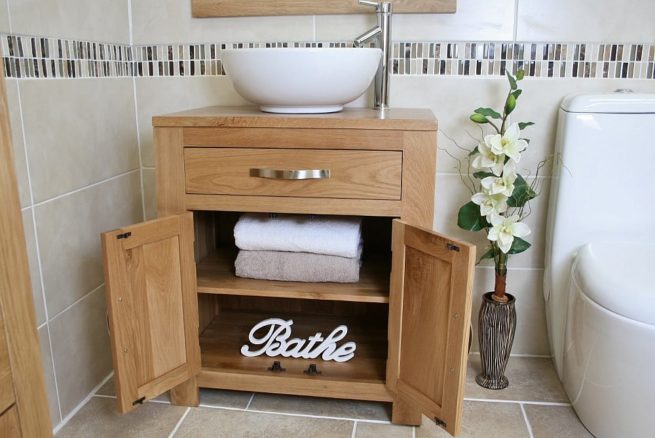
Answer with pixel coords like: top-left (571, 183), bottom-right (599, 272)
top-left (475, 292), bottom-right (516, 389)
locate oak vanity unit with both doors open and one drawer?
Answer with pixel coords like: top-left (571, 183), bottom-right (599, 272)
top-left (103, 107), bottom-right (475, 434)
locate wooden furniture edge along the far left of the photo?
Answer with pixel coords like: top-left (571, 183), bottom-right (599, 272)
top-left (0, 64), bottom-right (52, 438)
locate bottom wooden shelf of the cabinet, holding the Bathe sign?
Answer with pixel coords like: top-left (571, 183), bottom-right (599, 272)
top-left (199, 311), bottom-right (391, 401)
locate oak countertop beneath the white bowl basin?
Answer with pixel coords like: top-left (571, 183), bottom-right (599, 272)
top-left (152, 106), bottom-right (437, 131)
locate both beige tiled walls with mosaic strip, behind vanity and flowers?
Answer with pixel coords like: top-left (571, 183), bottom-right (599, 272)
top-left (0, 0), bottom-right (655, 432)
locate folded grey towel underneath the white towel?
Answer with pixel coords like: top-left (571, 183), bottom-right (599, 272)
top-left (234, 250), bottom-right (360, 283)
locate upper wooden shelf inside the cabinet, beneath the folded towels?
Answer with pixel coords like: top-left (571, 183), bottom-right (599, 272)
top-left (196, 250), bottom-right (389, 303)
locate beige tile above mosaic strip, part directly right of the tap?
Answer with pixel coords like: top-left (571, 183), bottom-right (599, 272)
top-left (392, 0), bottom-right (514, 41)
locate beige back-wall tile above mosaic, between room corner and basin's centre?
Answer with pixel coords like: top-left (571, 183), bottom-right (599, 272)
top-left (132, 0), bottom-right (314, 44)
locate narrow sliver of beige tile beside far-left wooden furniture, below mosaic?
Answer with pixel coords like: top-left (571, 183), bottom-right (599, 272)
top-left (5, 79), bottom-right (31, 207)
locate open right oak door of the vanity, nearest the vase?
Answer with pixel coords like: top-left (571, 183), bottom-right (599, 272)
top-left (387, 220), bottom-right (475, 435)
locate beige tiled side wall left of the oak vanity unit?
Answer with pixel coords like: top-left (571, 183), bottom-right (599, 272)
top-left (0, 0), bottom-right (144, 427)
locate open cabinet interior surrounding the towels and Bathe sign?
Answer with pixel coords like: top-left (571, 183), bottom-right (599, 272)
top-left (194, 212), bottom-right (392, 383)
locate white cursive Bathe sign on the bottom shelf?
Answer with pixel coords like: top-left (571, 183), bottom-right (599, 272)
top-left (241, 318), bottom-right (357, 362)
